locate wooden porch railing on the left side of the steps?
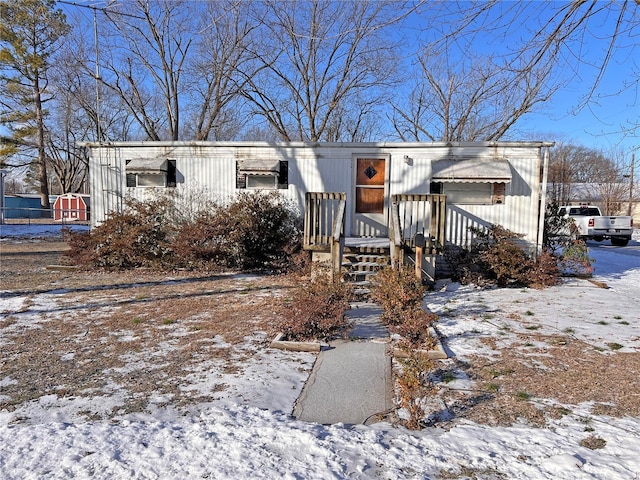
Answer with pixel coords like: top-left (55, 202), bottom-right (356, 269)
top-left (303, 192), bottom-right (347, 279)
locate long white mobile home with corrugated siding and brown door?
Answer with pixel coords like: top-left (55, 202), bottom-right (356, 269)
top-left (85, 142), bottom-right (553, 278)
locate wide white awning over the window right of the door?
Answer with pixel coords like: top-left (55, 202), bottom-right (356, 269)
top-left (432, 158), bottom-right (511, 183)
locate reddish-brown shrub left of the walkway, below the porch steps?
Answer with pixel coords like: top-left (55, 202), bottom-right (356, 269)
top-left (278, 277), bottom-right (352, 340)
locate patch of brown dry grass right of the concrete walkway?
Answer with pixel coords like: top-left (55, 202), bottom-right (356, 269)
top-left (432, 333), bottom-right (640, 427)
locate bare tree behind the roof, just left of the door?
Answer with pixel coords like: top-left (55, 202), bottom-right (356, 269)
top-left (238, 0), bottom-right (409, 141)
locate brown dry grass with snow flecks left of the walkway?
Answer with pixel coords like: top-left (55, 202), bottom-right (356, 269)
top-left (0, 241), bottom-right (293, 416)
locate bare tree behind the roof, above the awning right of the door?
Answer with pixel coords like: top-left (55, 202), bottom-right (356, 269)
top-left (392, 0), bottom-right (640, 140)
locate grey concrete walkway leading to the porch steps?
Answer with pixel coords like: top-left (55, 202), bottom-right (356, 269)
top-left (293, 303), bottom-right (393, 424)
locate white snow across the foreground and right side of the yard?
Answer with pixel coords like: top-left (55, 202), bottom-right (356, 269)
top-left (0, 226), bottom-right (640, 480)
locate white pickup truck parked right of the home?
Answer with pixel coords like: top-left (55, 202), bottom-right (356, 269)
top-left (558, 205), bottom-right (633, 247)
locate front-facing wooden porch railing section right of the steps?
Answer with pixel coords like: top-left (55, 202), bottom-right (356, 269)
top-left (389, 194), bottom-right (446, 256)
